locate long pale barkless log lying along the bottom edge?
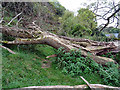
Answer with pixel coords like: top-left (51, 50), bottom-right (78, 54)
top-left (11, 84), bottom-right (120, 90)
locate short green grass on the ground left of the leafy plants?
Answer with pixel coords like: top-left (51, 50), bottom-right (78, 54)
top-left (2, 45), bottom-right (103, 89)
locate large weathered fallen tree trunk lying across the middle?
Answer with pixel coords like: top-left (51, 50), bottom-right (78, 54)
top-left (0, 23), bottom-right (117, 64)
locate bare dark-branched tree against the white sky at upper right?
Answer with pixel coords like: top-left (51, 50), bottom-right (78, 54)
top-left (87, 0), bottom-right (120, 31)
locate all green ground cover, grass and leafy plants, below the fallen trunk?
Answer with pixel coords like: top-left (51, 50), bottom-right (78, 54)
top-left (2, 45), bottom-right (120, 89)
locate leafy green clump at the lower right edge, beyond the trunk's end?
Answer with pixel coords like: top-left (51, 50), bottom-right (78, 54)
top-left (99, 63), bottom-right (120, 86)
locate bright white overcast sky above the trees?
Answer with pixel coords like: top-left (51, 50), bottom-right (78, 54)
top-left (58, 0), bottom-right (120, 26)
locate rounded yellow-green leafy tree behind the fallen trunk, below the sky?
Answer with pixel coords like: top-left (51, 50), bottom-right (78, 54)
top-left (60, 9), bottom-right (97, 37)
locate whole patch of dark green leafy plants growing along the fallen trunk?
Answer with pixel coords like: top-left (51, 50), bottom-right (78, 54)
top-left (55, 48), bottom-right (120, 86)
